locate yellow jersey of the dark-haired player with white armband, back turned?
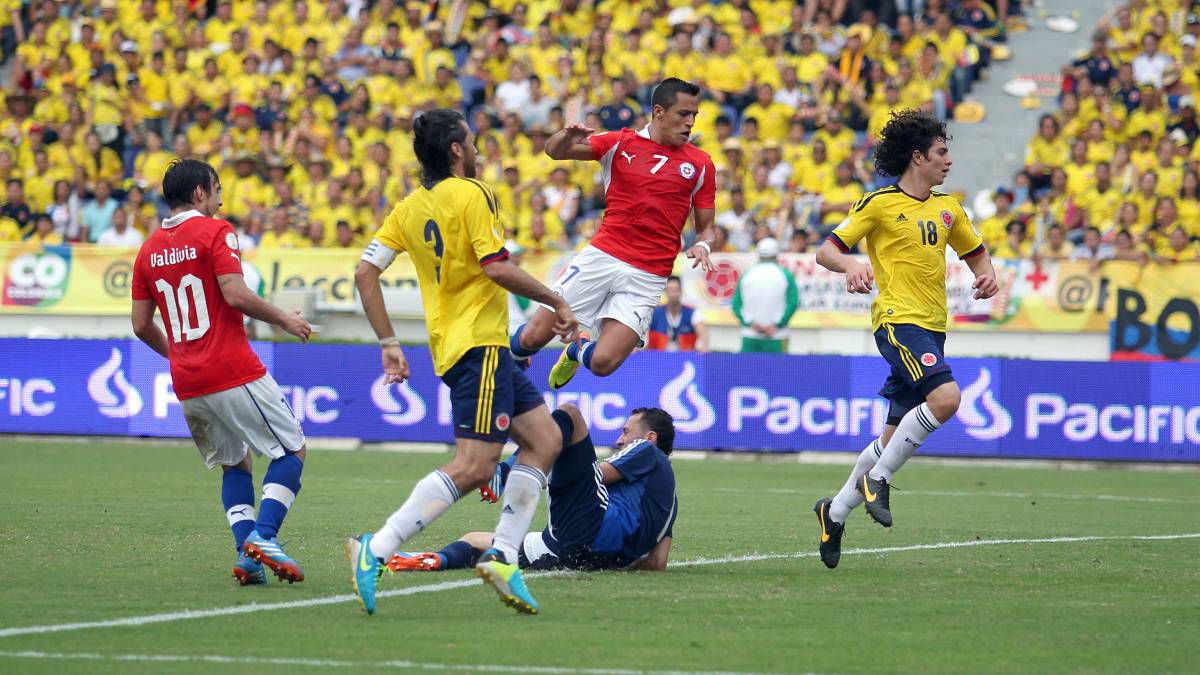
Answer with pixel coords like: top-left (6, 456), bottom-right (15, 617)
top-left (362, 177), bottom-right (509, 376)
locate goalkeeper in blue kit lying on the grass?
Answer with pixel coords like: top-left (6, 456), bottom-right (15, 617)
top-left (388, 404), bottom-right (679, 572)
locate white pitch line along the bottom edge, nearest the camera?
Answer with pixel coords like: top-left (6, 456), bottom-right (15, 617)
top-left (0, 651), bottom-right (758, 675)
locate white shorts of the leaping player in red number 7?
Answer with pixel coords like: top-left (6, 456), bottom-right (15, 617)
top-left (547, 245), bottom-right (667, 342)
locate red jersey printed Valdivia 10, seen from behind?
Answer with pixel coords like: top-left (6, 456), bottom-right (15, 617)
top-left (132, 211), bottom-right (266, 400)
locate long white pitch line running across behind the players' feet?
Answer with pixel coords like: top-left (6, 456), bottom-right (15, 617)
top-left (0, 532), bottom-right (1200, 638)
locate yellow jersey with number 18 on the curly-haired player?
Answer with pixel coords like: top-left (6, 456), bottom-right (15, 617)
top-left (829, 185), bottom-right (984, 331)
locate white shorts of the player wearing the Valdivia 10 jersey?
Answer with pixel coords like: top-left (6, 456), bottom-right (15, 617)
top-left (180, 374), bottom-right (304, 468)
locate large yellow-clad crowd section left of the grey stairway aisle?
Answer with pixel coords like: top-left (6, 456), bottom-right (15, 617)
top-left (0, 0), bottom-right (1012, 251)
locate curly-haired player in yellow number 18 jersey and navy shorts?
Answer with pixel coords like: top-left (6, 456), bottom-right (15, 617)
top-left (814, 109), bottom-right (998, 568)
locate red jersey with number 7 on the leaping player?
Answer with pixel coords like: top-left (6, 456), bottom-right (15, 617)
top-left (588, 127), bottom-right (716, 276)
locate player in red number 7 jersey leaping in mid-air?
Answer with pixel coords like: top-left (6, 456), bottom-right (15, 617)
top-left (510, 78), bottom-right (716, 389)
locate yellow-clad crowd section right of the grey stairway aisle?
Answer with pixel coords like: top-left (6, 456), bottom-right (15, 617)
top-left (1003, 0), bottom-right (1200, 263)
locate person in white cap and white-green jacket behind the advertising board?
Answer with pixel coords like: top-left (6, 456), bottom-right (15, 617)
top-left (733, 238), bottom-right (799, 353)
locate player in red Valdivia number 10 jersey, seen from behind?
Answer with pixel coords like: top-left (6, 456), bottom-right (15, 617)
top-left (132, 160), bottom-right (312, 586)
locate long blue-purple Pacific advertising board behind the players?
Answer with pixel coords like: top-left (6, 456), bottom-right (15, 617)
top-left (0, 339), bottom-right (1200, 461)
